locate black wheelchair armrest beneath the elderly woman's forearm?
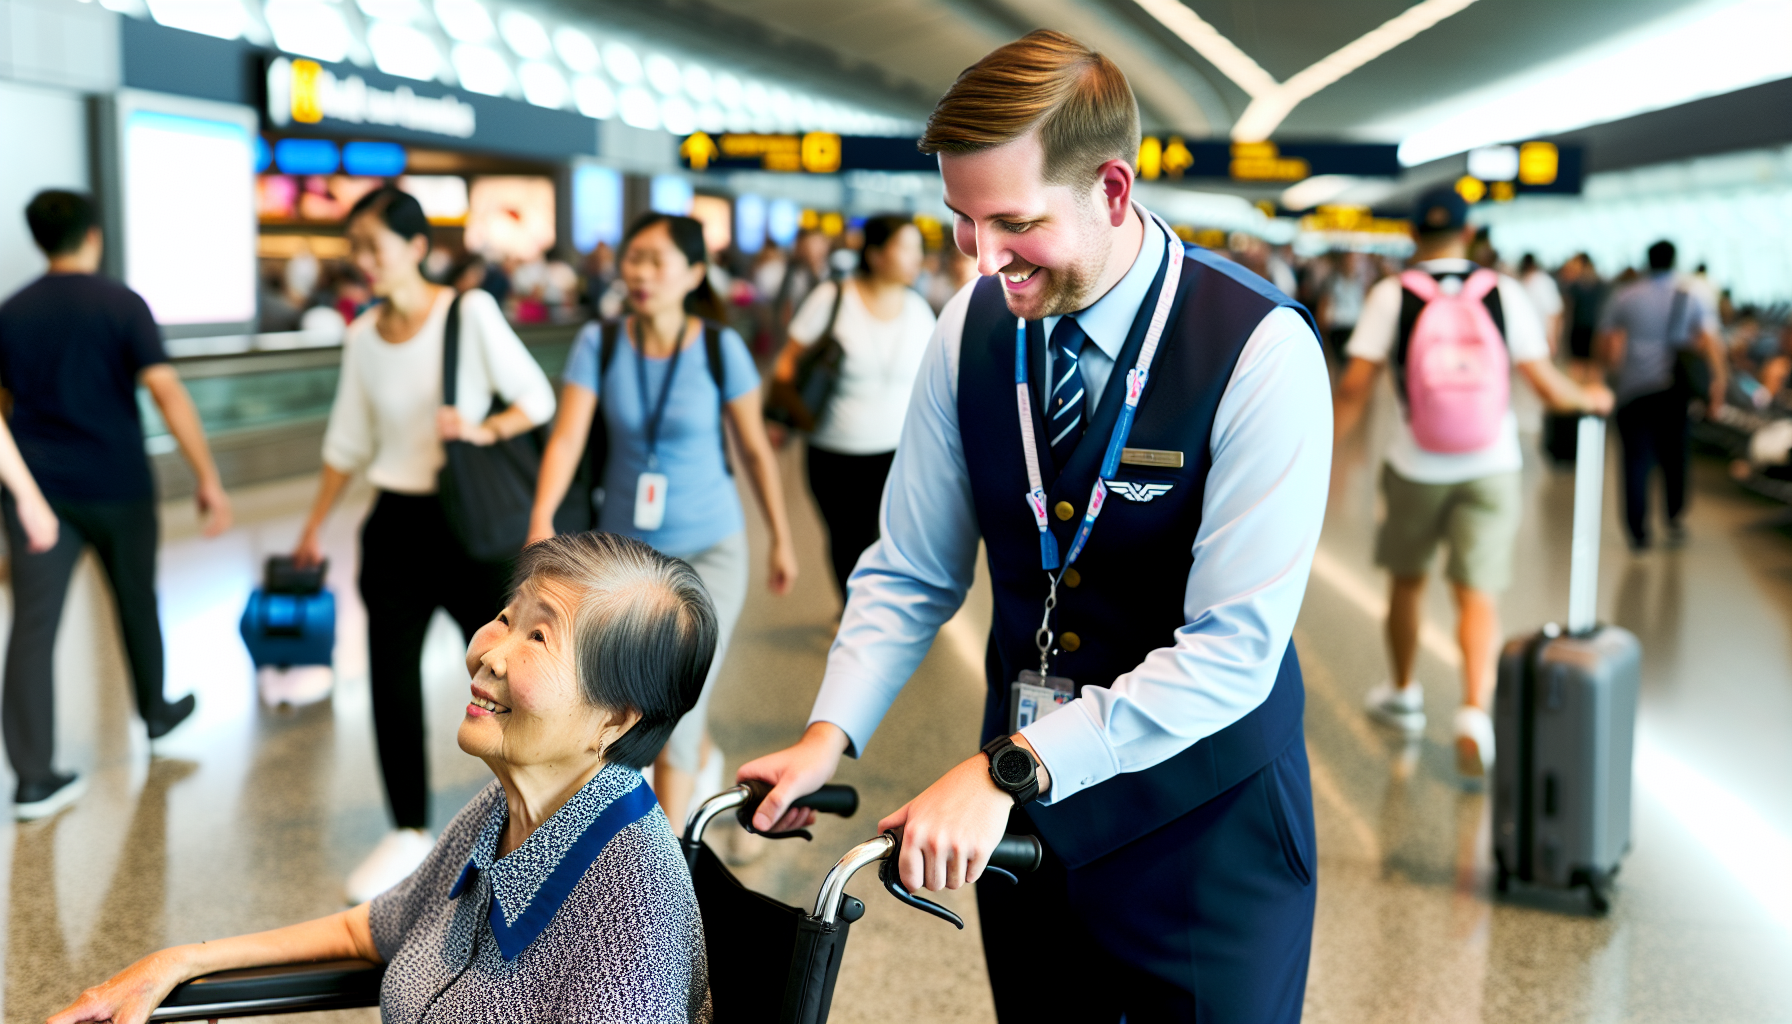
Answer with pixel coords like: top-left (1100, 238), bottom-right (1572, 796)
top-left (149, 959), bottom-right (385, 1020)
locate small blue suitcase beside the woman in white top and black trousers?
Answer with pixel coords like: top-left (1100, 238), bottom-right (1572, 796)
top-left (240, 556), bottom-right (335, 707)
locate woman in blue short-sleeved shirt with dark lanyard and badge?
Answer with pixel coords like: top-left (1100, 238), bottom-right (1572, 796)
top-left (529, 213), bottom-right (796, 821)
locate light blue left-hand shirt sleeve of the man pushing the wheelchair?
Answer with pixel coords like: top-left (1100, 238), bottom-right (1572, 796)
top-left (808, 282), bottom-right (978, 757)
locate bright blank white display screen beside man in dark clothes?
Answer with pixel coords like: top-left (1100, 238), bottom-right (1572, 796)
top-left (120, 109), bottom-right (256, 325)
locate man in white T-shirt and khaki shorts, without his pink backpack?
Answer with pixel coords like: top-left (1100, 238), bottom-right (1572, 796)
top-left (1333, 188), bottom-right (1611, 780)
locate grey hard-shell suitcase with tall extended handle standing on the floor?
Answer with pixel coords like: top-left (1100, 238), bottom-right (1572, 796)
top-left (1493, 416), bottom-right (1641, 913)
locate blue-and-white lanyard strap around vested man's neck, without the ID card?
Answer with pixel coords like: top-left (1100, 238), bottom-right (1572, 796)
top-left (1014, 206), bottom-right (1183, 674)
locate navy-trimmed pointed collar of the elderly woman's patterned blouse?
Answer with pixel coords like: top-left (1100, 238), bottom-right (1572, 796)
top-left (448, 764), bottom-right (658, 959)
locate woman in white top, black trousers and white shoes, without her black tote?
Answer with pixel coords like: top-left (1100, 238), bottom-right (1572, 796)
top-left (294, 187), bottom-right (554, 904)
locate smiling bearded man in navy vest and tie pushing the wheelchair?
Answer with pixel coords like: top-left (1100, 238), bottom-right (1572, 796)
top-left (740, 30), bottom-right (1331, 1024)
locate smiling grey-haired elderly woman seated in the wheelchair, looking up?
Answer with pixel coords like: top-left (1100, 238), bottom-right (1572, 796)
top-left (50, 534), bottom-right (717, 1024)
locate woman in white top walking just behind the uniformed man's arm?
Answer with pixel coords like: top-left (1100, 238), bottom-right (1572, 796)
top-left (776, 215), bottom-right (934, 599)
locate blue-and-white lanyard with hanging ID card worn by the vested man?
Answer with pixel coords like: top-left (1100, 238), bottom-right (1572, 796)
top-left (1009, 206), bottom-right (1185, 733)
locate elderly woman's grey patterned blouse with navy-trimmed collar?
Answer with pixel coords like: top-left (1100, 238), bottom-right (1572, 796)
top-left (371, 764), bottom-right (710, 1024)
